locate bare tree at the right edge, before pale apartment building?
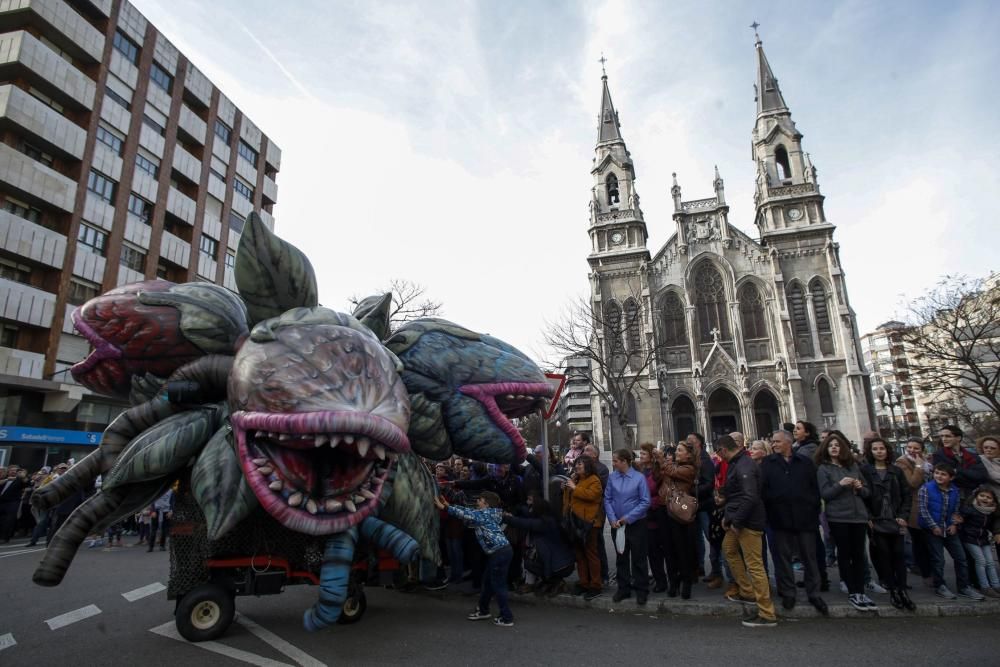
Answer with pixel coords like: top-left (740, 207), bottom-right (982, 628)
top-left (903, 276), bottom-right (1000, 417)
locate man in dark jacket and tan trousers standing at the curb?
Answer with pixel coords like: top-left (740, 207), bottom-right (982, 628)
top-left (716, 435), bottom-right (778, 628)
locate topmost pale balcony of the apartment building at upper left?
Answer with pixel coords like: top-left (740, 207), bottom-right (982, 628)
top-left (0, 0), bottom-right (104, 63)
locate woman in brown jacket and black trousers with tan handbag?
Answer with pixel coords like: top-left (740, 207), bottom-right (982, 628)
top-left (660, 443), bottom-right (701, 600)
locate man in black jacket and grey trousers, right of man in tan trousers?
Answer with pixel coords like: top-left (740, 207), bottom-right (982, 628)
top-left (760, 431), bottom-right (828, 616)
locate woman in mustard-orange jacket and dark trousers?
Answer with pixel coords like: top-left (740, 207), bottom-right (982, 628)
top-left (563, 456), bottom-right (604, 601)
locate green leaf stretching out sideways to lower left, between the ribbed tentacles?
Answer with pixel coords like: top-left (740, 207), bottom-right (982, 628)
top-left (101, 406), bottom-right (222, 489)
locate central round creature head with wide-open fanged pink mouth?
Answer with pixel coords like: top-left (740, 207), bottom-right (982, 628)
top-left (228, 308), bottom-right (410, 535)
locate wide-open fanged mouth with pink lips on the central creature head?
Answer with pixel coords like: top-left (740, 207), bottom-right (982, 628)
top-left (231, 411), bottom-right (410, 535)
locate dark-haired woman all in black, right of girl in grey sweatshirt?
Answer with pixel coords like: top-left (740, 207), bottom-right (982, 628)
top-left (861, 438), bottom-right (917, 611)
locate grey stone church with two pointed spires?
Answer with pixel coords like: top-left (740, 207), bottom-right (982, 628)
top-left (588, 37), bottom-right (873, 449)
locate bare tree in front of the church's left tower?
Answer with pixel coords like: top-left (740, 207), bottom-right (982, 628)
top-left (543, 288), bottom-right (658, 449)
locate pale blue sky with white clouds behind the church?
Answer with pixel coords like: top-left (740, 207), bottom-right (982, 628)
top-left (132, 0), bottom-right (1000, 366)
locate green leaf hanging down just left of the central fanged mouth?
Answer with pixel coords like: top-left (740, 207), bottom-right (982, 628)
top-left (191, 426), bottom-right (257, 540)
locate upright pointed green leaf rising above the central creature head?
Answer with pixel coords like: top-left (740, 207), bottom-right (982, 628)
top-left (235, 213), bottom-right (319, 327)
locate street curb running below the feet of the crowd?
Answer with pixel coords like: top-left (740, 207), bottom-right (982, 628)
top-left (510, 593), bottom-right (1000, 620)
